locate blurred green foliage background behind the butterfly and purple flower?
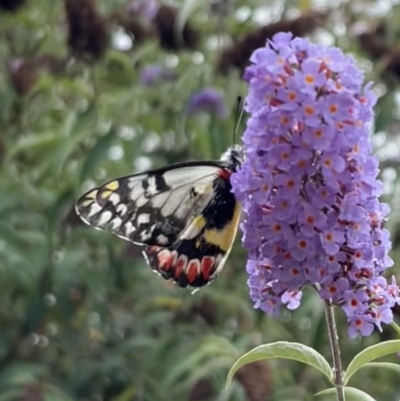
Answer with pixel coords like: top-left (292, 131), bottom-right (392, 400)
top-left (0, 0), bottom-right (400, 401)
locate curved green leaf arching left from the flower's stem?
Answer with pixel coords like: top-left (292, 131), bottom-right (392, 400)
top-left (225, 341), bottom-right (332, 388)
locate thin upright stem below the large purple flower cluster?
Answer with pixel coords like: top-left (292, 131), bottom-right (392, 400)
top-left (325, 302), bottom-right (345, 401)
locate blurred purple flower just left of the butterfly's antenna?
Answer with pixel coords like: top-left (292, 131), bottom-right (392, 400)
top-left (187, 87), bottom-right (228, 118)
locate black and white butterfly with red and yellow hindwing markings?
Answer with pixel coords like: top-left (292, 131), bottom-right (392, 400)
top-left (75, 146), bottom-right (243, 288)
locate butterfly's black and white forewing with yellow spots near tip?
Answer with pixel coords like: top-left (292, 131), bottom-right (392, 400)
top-left (76, 163), bottom-right (225, 245)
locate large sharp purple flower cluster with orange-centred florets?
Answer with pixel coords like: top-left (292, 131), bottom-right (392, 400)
top-left (232, 33), bottom-right (400, 336)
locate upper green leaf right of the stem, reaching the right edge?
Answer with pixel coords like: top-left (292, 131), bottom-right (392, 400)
top-left (344, 340), bottom-right (400, 384)
